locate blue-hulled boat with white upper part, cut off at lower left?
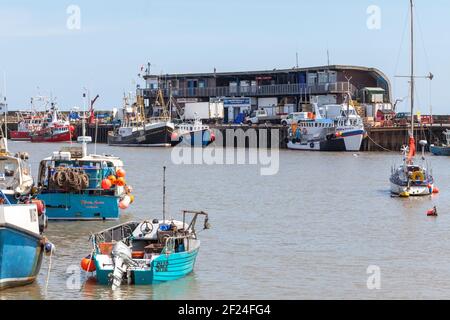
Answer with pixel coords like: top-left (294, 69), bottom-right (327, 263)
top-left (0, 191), bottom-right (53, 289)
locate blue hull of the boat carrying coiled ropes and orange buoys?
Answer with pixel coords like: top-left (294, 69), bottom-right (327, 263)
top-left (39, 193), bottom-right (120, 220)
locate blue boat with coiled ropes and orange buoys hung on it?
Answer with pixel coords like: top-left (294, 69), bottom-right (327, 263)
top-left (38, 92), bottom-right (134, 220)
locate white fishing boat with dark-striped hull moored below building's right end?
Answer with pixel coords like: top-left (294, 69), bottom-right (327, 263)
top-left (287, 95), bottom-right (365, 151)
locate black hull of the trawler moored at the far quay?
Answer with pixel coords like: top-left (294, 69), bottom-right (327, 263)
top-left (108, 123), bottom-right (174, 147)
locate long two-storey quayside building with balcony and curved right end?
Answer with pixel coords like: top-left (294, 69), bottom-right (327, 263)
top-left (137, 65), bottom-right (392, 123)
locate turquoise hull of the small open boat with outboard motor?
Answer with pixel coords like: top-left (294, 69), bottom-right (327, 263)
top-left (94, 248), bottom-right (199, 285)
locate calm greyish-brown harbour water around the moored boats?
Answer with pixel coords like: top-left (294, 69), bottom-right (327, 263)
top-left (0, 142), bottom-right (450, 299)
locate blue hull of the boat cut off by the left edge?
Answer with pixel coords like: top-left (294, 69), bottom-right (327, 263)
top-left (0, 224), bottom-right (43, 289)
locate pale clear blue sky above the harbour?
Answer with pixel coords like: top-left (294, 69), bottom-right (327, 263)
top-left (0, 0), bottom-right (450, 114)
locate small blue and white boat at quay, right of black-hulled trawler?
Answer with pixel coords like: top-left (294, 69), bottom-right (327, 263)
top-left (171, 119), bottom-right (216, 147)
